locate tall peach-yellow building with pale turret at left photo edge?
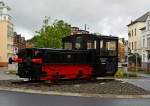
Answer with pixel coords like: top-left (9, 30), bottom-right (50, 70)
top-left (0, 2), bottom-right (13, 66)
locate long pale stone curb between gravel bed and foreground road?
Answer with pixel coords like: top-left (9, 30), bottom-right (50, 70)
top-left (0, 87), bottom-right (150, 99)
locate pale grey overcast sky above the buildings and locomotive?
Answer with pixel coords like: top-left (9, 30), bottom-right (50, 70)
top-left (3, 0), bottom-right (150, 39)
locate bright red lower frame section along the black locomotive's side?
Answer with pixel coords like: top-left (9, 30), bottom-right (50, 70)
top-left (41, 64), bottom-right (93, 80)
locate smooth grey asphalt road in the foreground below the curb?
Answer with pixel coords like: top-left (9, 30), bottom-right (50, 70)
top-left (0, 91), bottom-right (150, 106)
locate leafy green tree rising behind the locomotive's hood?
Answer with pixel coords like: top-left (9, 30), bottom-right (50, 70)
top-left (31, 17), bottom-right (71, 48)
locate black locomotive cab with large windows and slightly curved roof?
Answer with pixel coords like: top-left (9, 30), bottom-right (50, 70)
top-left (62, 34), bottom-right (118, 77)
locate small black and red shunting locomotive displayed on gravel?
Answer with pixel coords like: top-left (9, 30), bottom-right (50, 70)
top-left (16, 34), bottom-right (118, 81)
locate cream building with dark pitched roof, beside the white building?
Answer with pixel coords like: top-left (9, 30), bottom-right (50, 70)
top-left (127, 13), bottom-right (148, 54)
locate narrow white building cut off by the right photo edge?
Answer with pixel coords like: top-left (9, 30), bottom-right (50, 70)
top-left (141, 12), bottom-right (150, 69)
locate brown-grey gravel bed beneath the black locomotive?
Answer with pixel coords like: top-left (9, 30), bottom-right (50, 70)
top-left (0, 79), bottom-right (150, 95)
